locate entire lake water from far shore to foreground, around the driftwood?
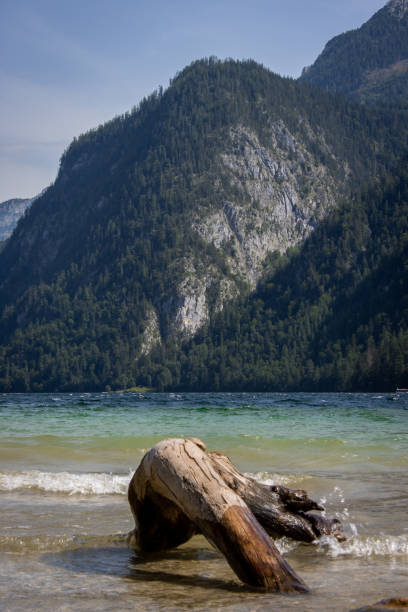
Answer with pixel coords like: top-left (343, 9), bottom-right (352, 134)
top-left (0, 394), bottom-right (408, 611)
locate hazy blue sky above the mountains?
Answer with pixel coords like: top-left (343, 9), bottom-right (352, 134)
top-left (0, 0), bottom-right (385, 202)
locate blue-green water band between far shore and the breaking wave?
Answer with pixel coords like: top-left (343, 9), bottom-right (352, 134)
top-left (0, 393), bottom-right (408, 471)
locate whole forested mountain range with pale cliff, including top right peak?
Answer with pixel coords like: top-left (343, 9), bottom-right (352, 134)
top-left (0, 0), bottom-right (408, 391)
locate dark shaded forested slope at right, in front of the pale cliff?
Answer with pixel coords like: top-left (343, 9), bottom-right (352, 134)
top-left (147, 158), bottom-right (408, 391)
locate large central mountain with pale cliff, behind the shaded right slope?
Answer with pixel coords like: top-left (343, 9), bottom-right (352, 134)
top-left (0, 58), bottom-right (408, 391)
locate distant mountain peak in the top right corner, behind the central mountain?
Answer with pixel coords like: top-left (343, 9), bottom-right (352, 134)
top-left (300, 0), bottom-right (408, 104)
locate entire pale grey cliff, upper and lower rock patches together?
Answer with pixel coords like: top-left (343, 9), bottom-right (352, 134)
top-left (165, 121), bottom-right (342, 337)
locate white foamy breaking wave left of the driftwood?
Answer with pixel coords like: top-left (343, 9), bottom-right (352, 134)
top-left (0, 470), bottom-right (131, 495)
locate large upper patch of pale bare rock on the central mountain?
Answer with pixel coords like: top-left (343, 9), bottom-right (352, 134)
top-left (196, 121), bottom-right (336, 288)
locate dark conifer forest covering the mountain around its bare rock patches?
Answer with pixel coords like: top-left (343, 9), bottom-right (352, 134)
top-left (0, 51), bottom-right (408, 391)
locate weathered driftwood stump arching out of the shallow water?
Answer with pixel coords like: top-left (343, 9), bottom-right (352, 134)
top-left (128, 438), bottom-right (343, 593)
